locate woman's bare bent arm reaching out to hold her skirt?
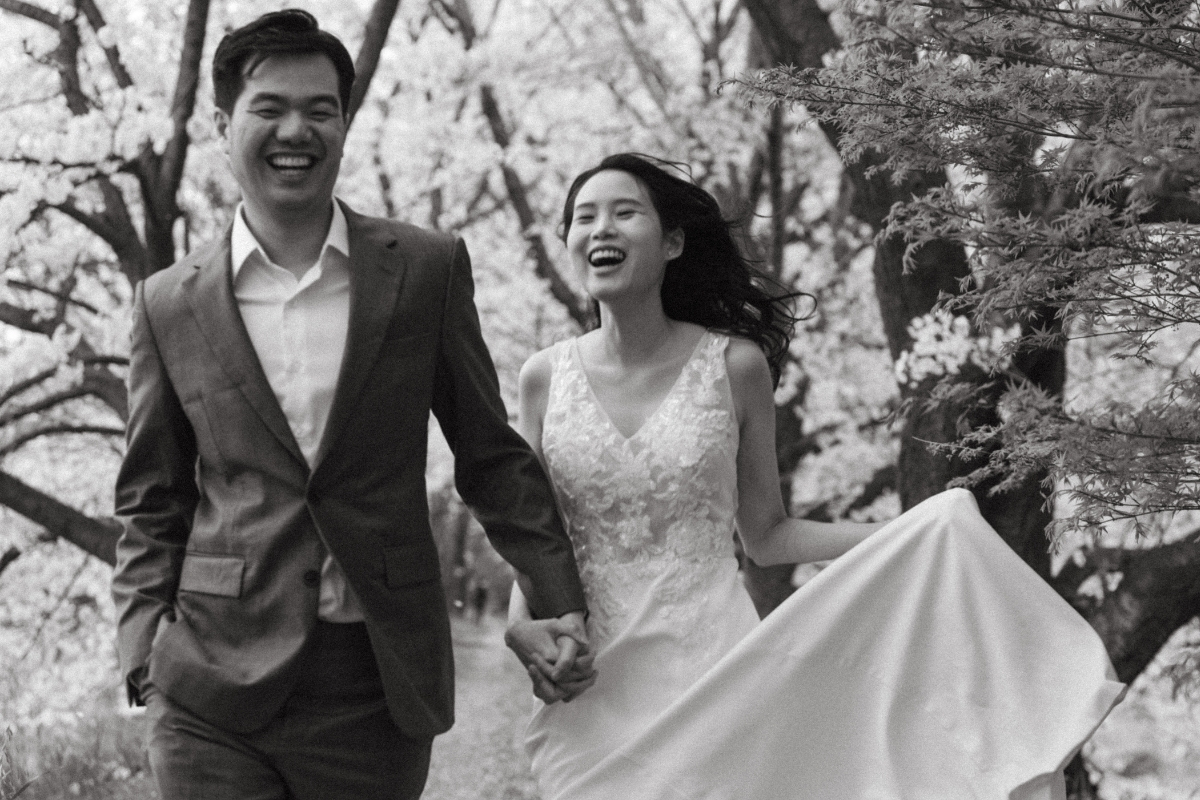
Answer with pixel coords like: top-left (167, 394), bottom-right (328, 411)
top-left (726, 338), bottom-right (883, 566)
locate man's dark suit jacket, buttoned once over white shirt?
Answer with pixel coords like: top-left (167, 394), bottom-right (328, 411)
top-left (113, 209), bottom-right (584, 735)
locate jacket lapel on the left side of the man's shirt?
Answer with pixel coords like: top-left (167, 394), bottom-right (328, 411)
top-left (187, 230), bottom-right (308, 469)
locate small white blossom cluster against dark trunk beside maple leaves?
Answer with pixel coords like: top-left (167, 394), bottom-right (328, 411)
top-left (895, 309), bottom-right (1021, 386)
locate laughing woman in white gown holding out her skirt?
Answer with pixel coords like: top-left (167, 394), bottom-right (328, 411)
top-left (506, 155), bottom-right (1123, 800)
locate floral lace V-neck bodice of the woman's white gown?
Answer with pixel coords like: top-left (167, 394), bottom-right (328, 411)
top-left (541, 331), bottom-right (738, 648)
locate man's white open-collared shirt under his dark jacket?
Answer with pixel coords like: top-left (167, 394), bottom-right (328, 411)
top-left (229, 201), bottom-right (362, 622)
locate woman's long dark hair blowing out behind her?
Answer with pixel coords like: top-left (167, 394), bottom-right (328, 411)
top-left (562, 152), bottom-right (804, 384)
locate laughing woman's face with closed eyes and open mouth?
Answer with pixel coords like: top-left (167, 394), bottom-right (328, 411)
top-left (566, 169), bottom-right (683, 302)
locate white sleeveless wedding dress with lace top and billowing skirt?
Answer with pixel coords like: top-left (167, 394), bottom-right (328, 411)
top-left (527, 332), bottom-right (1124, 800)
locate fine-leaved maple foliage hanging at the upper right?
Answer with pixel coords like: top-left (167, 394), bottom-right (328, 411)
top-left (758, 0), bottom-right (1200, 530)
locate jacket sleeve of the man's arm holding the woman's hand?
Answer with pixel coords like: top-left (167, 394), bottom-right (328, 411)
top-left (433, 239), bottom-right (586, 618)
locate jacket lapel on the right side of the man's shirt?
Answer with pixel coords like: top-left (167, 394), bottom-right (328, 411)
top-left (313, 205), bottom-right (406, 470)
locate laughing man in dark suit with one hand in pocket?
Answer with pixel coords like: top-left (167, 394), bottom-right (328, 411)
top-left (113, 11), bottom-right (586, 800)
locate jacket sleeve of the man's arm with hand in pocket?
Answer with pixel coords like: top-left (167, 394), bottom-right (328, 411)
top-left (113, 282), bottom-right (199, 703)
